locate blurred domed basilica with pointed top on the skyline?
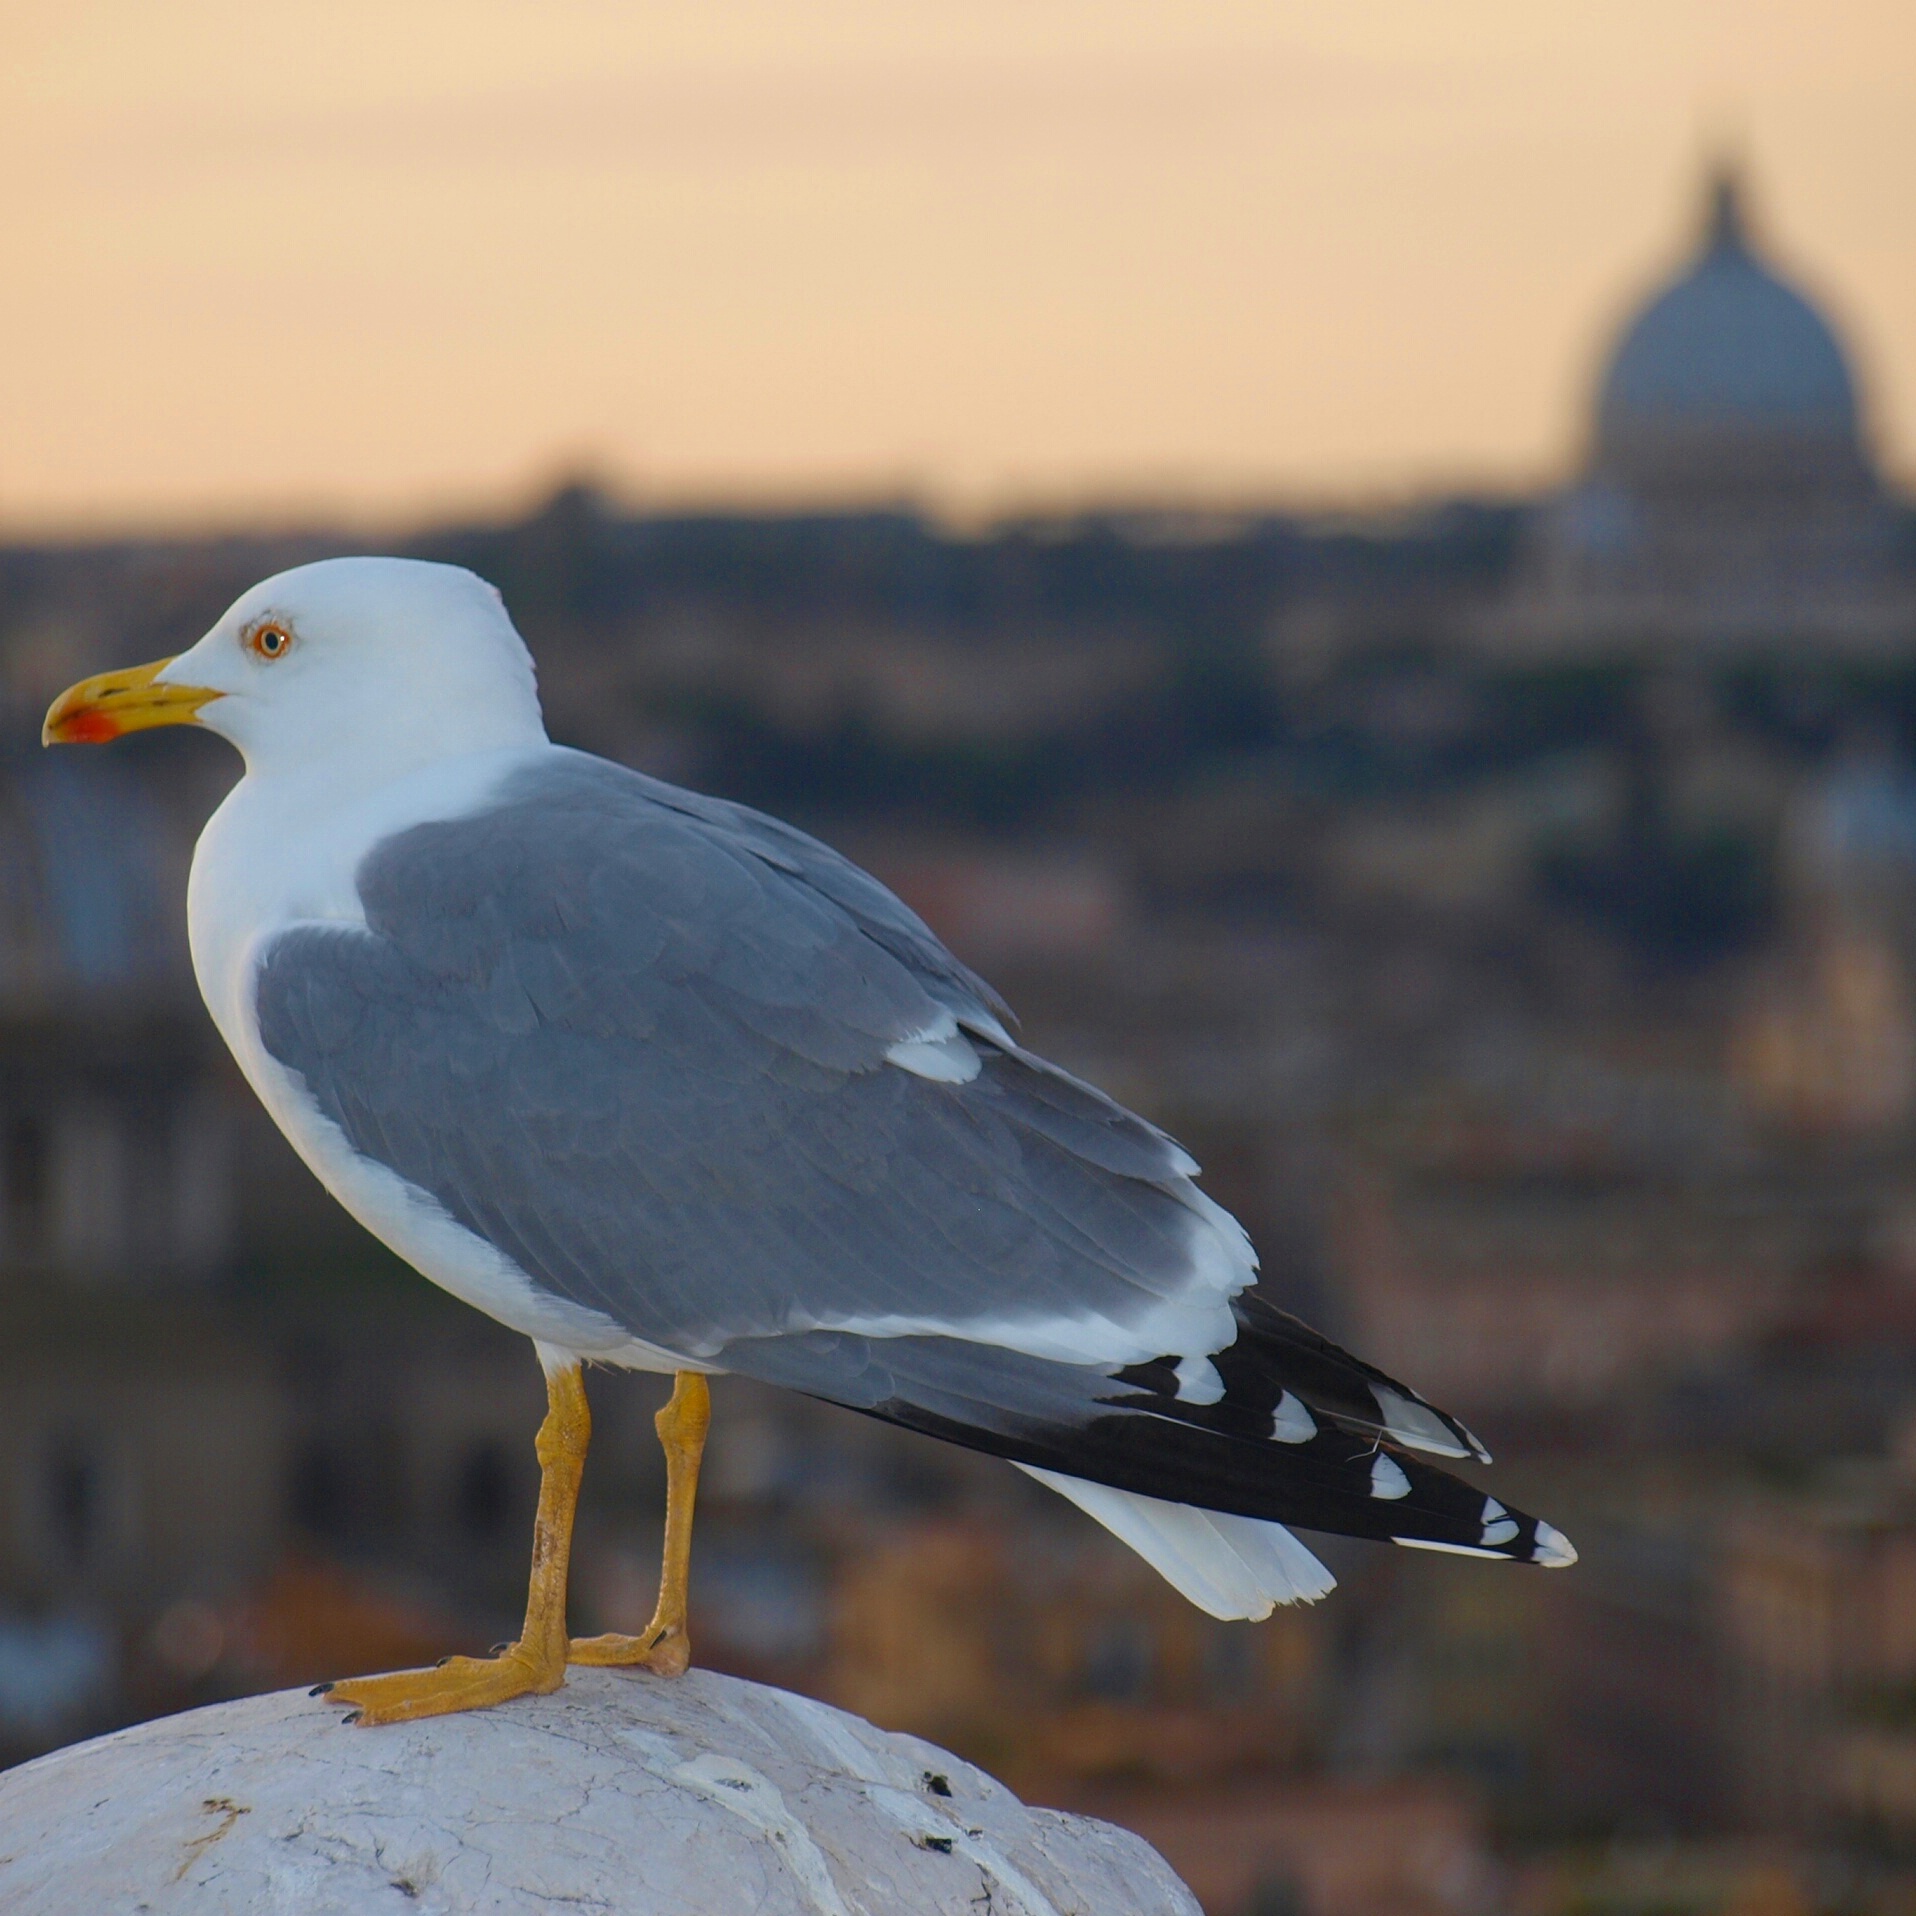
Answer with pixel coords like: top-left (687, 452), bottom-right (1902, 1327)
top-left (1483, 169), bottom-right (1916, 655)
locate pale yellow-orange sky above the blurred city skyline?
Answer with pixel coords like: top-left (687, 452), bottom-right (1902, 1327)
top-left (0, 0), bottom-right (1916, 533)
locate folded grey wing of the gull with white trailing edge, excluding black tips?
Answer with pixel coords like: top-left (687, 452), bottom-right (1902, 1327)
top-left (257, 755), bottom-right (1253, 1364)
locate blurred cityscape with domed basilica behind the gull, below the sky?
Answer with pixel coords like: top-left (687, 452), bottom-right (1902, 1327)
top-left (0, 172), bottom-right (1916, 1916)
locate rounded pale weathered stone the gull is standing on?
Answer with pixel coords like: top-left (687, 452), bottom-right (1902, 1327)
top-left (0, 1669), bottom-right (1198, 1916)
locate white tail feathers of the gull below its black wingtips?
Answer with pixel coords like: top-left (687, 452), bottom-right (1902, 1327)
top-left (1017, 1464), bottom-right (1337, 1621)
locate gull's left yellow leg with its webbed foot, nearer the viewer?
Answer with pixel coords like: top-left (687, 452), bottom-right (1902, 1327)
top-left (330, 1364), bottom-right (592, 1724)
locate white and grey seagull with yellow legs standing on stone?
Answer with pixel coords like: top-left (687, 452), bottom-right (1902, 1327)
top-left (42, 558), bottom-right (1577, 1724)
